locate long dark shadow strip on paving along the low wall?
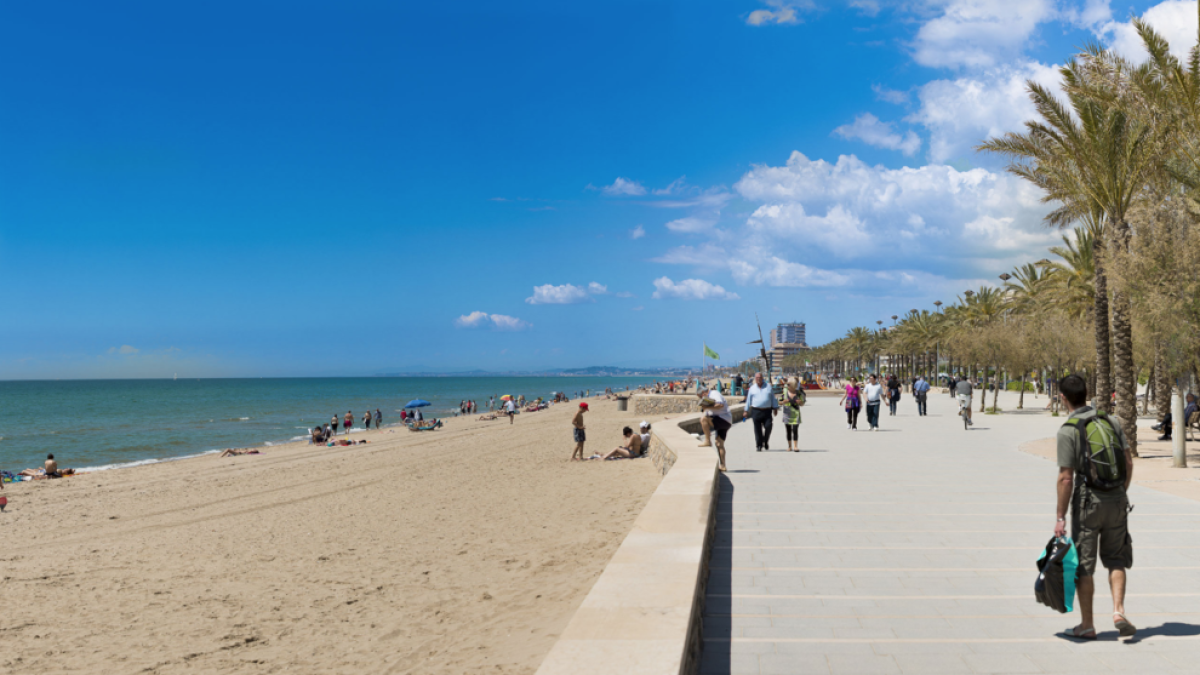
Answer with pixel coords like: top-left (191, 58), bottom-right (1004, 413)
top-left (697, 470), bottom-right (734, 675)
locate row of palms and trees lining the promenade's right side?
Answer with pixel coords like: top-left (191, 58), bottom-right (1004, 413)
top-left (812, 14), bottom-right (1200, 454)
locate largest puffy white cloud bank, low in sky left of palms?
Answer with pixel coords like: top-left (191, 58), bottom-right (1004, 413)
top-left (729, 153), bottom-right (1054, 264)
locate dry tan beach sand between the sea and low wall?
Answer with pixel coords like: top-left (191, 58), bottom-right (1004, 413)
top-left (0, 400), bottom-right (659, 675)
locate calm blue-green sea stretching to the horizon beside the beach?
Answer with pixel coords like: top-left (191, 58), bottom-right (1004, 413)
top-left (0, 377), bottom-right (653, 471)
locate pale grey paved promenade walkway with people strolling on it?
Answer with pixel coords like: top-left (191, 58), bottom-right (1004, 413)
top-left (701, 395), bottom-right (1200, 675)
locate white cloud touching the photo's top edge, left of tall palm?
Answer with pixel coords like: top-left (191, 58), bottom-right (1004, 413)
top-left (913, 0), bottom-right (1057, 67)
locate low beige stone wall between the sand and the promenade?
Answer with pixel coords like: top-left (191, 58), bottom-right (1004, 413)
top-left (538, 396), bottom-right (742, 675)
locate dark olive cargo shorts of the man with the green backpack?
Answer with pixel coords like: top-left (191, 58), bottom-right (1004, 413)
top-left (1070, 489), bottom-right (1133, 578)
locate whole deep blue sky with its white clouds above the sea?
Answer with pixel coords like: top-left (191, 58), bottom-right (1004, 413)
top-left (0, 0), bottom-right (1196, 378)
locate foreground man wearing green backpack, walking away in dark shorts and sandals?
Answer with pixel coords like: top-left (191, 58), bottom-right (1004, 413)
top-left (1054, 375), bottom-right (1138, 640)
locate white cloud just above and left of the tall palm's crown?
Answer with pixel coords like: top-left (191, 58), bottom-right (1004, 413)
top-left (906, 61), bottom-right (1062, 162)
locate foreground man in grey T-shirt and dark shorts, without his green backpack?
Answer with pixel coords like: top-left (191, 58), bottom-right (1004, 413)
top-left (1054, 375), bottom-right (1138, 640)
